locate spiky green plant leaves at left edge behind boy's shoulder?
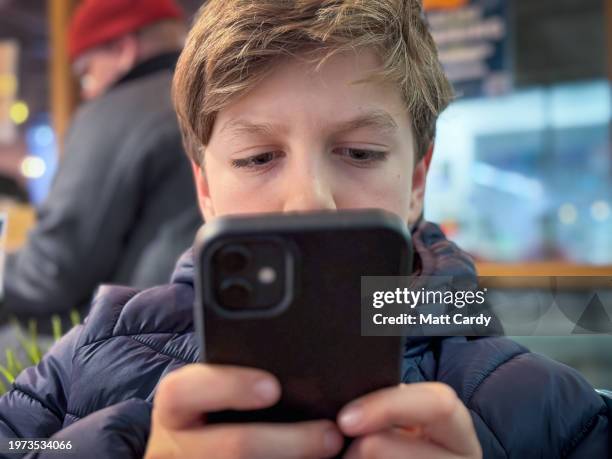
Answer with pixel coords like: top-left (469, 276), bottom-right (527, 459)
top-left (0, 310), bottom-right (81, 394)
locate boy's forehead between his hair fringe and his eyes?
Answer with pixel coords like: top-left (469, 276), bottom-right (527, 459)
top-left (214, 50), bottom-right (409, 134)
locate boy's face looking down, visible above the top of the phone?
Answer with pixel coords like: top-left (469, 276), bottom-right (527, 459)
top-left (194, 51), bottom-right (427, 223)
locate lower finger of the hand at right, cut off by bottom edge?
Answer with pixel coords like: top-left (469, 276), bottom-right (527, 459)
top-left (344, 430), bottom-right (461, 459)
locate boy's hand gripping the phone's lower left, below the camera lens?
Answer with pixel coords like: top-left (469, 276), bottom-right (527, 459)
top-left (145, 364), bottom-right (342, 459)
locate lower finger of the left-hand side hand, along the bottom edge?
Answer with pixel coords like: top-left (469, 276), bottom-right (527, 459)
top-left (166, 421), bottom-right (343, 459)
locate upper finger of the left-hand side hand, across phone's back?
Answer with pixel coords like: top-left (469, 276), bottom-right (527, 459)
top-left (153, 364), bottom-right (281, 429)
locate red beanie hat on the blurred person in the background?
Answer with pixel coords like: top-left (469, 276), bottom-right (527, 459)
top-left (68, 0), bottom-right (183, 61)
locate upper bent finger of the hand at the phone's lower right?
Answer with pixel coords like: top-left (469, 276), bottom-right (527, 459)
top-left (338, 383), bottom-right (480, 454)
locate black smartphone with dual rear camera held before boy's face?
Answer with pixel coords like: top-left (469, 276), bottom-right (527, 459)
top-left (195, 210), bottom-right (412, 422)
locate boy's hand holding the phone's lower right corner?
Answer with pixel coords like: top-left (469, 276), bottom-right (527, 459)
top-left (338, 382), bottom-right (482, 459)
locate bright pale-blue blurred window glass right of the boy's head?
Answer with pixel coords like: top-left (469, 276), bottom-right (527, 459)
top-left (426, 81), bottom-right (612, 264)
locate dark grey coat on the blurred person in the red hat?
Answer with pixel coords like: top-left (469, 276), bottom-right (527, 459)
top-left (3, 53), bottom-right (202, 322)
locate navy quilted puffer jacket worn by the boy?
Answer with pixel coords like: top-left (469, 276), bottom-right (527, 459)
top-left (0, 223), bottom-right (611, 459)
